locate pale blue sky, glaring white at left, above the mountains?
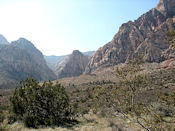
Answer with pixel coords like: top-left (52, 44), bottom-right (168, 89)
top-left (0, 0), bottom-right (159, 55)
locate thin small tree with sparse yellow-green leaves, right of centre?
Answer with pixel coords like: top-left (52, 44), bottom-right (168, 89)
top-left (116, 55), bottom-right (147, 111)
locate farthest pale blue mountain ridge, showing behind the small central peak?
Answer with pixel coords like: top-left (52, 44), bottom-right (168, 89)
top-left (44, 51), bottom-right (94, 72)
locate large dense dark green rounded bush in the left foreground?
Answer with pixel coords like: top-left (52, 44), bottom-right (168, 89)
top-left (10, 78), bottom-right (76, 128)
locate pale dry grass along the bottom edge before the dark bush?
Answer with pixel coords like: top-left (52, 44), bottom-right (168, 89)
top-left (6, 113), bottom-right (144, 131)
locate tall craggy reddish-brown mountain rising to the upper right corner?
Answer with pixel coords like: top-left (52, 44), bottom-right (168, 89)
top-left (85, 0), bottom-right (175, 74)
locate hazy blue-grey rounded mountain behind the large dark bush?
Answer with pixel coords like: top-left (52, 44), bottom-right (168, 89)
top-left (0, 38), bottom-right (56, 88)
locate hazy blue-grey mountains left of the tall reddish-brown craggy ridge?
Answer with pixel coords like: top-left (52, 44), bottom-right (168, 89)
top-left (0, 35), bottom-right (94, 89)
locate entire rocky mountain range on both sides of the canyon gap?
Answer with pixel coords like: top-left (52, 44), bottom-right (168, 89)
top-left (0, 0), bottom-right (175, 88)
